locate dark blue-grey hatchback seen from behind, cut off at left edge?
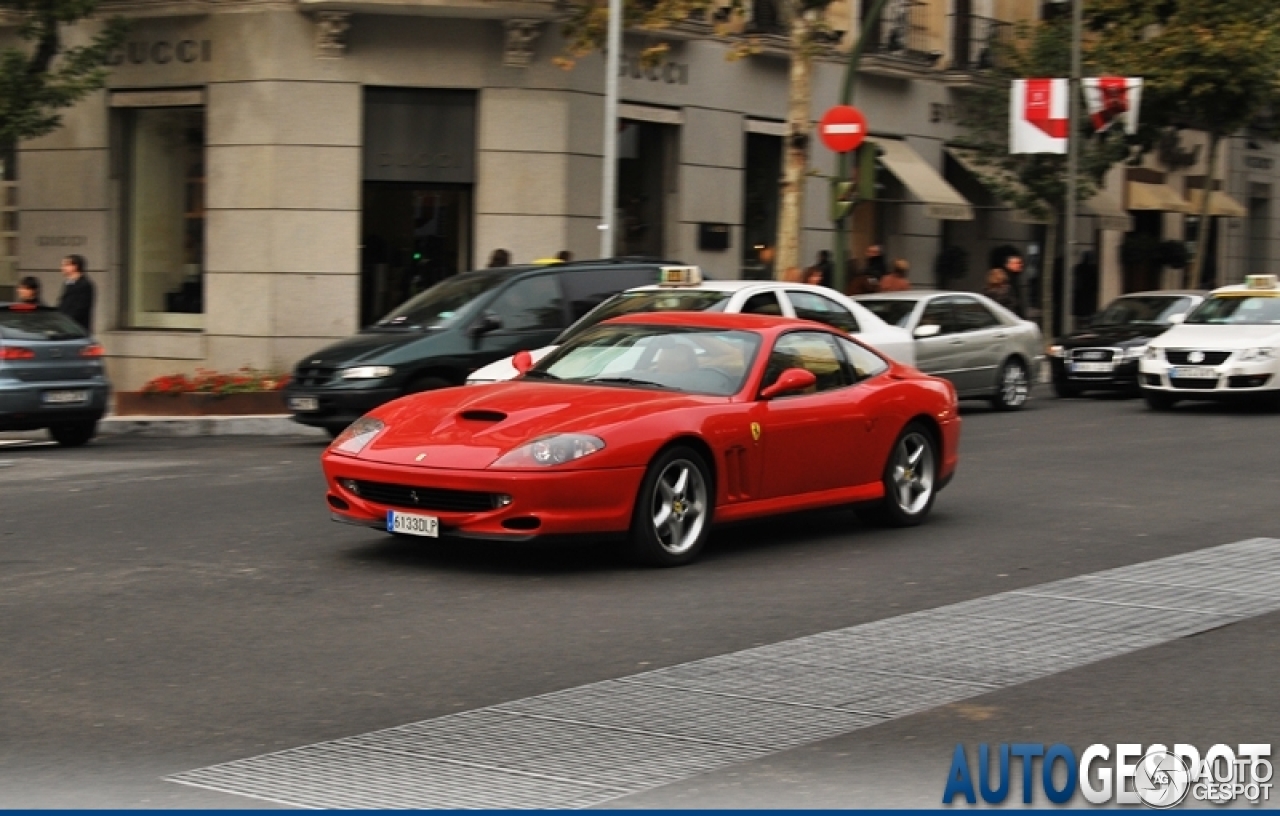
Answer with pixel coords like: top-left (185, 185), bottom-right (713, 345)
top-left (0, 303), bottom-right (111, 446)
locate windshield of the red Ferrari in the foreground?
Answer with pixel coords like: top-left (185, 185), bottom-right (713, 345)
top-left (525, 324), bottom-right (760, 396)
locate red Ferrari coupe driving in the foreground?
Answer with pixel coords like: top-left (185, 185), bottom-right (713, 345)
top-left (324, 312), bottom-right (960, 567)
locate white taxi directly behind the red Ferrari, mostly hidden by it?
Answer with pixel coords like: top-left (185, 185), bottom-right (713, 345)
top-left (467, 275), bottom-right (915, 385)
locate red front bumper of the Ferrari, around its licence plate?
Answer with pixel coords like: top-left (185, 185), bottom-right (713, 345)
top-left (324, 454), bottom-right (645, 541)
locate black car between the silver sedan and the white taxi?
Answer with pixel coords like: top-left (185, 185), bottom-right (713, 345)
top-left (1048, 292), bottom-right (1204, 396)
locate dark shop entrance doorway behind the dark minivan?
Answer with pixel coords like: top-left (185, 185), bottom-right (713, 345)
top-left (360, 182), bottom-right (471, 326)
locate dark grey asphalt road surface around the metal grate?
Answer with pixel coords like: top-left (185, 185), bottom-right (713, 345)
top-left (0, 394), bottom-right (1280, 808)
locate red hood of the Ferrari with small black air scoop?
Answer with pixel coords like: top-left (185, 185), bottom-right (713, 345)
top-left (360, 381), bottom-right (726, 469)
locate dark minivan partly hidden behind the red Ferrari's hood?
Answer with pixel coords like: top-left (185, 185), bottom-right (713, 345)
top-left (284, 258), bottom-right (673, 435)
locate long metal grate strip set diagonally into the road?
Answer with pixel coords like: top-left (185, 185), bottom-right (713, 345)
top-left (169, 538), bottom-right (1280, 808)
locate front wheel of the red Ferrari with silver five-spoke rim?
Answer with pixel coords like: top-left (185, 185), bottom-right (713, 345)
top-left (630, 445), bottom-right (716, 567)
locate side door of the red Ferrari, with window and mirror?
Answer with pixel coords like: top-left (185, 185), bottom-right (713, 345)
top-left (750, 331), bottom-right (867, 499)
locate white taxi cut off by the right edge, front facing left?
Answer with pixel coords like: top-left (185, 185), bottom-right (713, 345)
top-left (1138, 275), bottom-right (1280, 411)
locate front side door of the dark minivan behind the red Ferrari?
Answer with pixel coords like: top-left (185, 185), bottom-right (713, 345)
top-left (468, 274), bottom-right (564, 370)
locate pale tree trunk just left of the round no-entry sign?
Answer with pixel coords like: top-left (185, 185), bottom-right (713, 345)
top-left (773, 4), bottom-right (813, 280)
